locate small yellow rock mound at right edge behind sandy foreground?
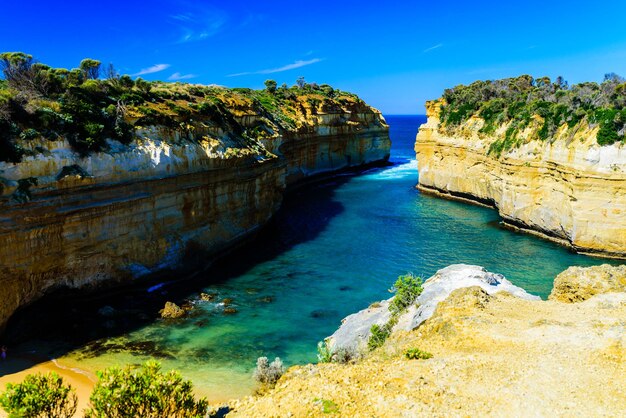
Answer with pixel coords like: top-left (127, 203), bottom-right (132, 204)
top-left (549, 264), bottom-right (626, 303)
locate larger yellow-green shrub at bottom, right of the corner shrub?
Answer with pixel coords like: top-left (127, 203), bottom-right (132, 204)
top-left (85, 361), bottom-right (208, 418)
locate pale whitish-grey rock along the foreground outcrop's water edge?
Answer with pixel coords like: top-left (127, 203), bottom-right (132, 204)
top-left (328, 264), bottom-right (540, 351)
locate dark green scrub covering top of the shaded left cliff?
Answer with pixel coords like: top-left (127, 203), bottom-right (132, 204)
top-left (0, 52), bottom-right (366, 162)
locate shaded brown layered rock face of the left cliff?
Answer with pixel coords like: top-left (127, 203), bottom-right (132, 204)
top-left (0, 96), bottom-right (390, 329)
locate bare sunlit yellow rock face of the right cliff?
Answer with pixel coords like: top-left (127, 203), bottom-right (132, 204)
top-left (415, 101), bottom-right (626, 258)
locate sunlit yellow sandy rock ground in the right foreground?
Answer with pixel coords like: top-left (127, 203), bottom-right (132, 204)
top-left (229, 266), bottom-right (626, 417)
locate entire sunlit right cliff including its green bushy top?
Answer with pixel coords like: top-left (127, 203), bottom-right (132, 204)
top-left (415, 77), bottom-right (626, 258)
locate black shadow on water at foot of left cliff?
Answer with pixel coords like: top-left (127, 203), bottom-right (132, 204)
top-left (0, 173), bottom-right (366, 376)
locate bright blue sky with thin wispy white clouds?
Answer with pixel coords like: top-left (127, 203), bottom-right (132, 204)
top-left (0, 0), bottom-right (626, 114)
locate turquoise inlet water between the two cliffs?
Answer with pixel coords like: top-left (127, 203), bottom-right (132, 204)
top-left (7, 116), bottom-right (616, 400)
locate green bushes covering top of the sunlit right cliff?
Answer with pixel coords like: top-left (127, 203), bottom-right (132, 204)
top-left (434, 73), bottom-right (626, 155)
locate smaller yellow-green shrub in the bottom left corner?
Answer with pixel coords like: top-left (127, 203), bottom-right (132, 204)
top-left (0, 373), bottom-right (77, 418)
